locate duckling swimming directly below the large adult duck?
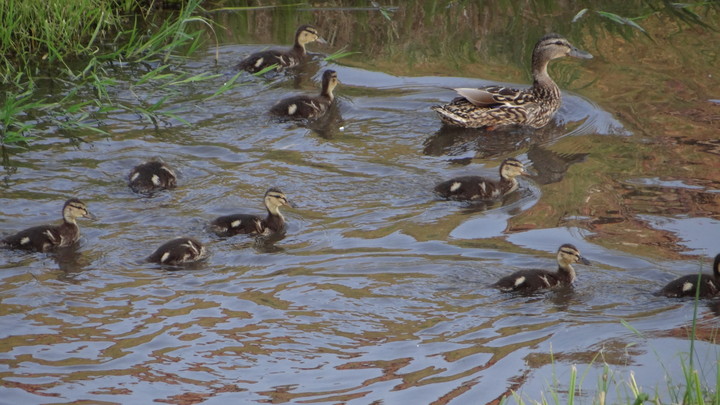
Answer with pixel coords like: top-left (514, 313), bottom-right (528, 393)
top-left (435, 158), bottom-right (527, 201)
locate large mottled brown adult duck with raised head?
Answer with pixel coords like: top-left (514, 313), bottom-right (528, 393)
top-left (432, 34), bottom-right (592, 129)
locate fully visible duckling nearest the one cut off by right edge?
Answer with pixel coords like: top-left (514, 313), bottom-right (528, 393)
top-left (493, 243), bottom-right (590, 293)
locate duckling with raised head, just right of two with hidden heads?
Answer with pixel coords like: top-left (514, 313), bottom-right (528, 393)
top-left (210, 188), bottom-right (292, 236)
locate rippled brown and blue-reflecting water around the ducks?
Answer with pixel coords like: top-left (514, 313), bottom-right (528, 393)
top-left (0, 1), bottom-right (720, 404)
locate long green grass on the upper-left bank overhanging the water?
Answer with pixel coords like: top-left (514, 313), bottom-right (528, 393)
top-left (0, 0), bottom-right (222, 147)
